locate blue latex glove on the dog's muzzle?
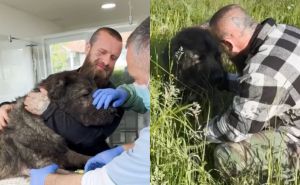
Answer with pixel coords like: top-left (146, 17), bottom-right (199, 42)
top-left (93, 88), bottom-right (128, 109)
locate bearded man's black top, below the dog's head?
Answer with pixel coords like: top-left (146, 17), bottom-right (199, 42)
top-left (42, 83), bottom-right (124, 156)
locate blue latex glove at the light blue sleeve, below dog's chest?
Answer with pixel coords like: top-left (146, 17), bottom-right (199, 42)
top-left (84, 146), bottom-right (124, 172)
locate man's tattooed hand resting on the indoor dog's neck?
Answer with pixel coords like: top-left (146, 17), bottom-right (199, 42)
top-left (24, 88), bottom-right (50, 115)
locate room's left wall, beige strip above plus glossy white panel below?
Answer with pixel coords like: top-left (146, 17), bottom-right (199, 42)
top-left (0, 4), bottom-right (62, 103)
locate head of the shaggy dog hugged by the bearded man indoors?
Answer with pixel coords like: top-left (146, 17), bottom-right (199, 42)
top-left (40, 71), bottom-right (118, 125)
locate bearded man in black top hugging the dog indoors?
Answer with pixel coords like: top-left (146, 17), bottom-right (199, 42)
top-left (0, 27), bottom-right (124, 156)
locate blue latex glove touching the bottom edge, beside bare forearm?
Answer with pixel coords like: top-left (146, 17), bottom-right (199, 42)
top-left (30, 164), bottom-right (58, 185)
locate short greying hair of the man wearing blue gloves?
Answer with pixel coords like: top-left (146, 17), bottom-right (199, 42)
top-left (126, 17), bottom-right (150, 52)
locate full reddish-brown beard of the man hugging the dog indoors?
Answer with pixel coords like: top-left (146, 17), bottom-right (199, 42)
top-left (79, 55), bottom-right (112, 87)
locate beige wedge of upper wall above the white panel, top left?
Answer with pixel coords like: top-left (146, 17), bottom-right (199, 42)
top-left (0, 4), bottom-right (62, 38)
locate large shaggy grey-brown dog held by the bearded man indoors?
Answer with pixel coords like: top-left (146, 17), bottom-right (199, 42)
top-left (0, 71), bottom-right (118, 179)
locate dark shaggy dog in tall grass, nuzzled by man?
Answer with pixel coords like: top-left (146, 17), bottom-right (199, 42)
top-left (164, 27), bottom-right (226, 102)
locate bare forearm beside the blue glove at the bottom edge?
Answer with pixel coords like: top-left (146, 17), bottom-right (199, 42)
top-left (45, 174), bottom-right (82, 185)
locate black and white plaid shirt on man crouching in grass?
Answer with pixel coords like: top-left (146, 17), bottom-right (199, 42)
top-left (206, 19), bottom-right (300, 143)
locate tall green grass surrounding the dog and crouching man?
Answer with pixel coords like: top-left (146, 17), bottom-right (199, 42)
top-left (151, 0), bottom-right (300, 185)
